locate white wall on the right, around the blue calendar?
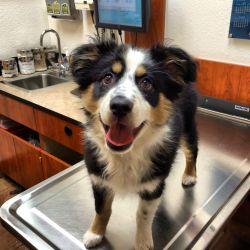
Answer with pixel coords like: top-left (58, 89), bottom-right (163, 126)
top-left (165, 0), bottom-right (250, 65)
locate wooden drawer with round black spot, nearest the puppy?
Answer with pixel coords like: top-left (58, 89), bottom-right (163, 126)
top-left (34, 110), bottom-right (83, 154)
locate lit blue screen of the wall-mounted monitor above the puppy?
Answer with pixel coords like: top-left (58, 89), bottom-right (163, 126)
top-left (98, 0), bottom-right (142, 27)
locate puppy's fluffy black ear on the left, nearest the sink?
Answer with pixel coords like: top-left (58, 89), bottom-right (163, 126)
top-left (70, 41), bottom-right (117, 90)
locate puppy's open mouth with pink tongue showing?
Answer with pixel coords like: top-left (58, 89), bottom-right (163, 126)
top-left (101, 120), bottom-right (144, 151)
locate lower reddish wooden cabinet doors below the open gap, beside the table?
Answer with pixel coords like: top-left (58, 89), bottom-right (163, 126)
top-left (0, 129), bottom-right (73, 188)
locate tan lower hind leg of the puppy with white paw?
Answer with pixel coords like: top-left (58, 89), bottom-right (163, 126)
top-left (181, 137), bottom-right (196, 186)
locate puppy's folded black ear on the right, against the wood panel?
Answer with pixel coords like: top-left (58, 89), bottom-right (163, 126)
top-left (151, 45), bottom-right (197, 85)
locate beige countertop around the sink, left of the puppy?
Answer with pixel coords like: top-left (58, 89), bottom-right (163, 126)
top-left (0, 72), bottom-right (83, 123)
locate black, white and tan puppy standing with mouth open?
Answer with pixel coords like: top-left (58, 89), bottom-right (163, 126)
top-left (71, 41), bottom-right (197, 250)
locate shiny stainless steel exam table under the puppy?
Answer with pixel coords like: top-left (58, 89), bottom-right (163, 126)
top-left (1, 109), bottom-right (250, 250)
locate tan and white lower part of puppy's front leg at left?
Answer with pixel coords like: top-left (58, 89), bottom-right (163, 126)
top-left (83, 192), bottom-right (114, 248)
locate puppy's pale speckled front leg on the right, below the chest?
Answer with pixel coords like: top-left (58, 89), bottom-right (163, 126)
top-left (134, 198), bottom-right (160, 250)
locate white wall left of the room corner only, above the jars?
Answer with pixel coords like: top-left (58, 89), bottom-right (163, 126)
top-left (0, 0), bottom-right (50, 59)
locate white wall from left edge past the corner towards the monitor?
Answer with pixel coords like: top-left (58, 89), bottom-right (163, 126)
top-left (0, 0), bottom-right (95, 59)
